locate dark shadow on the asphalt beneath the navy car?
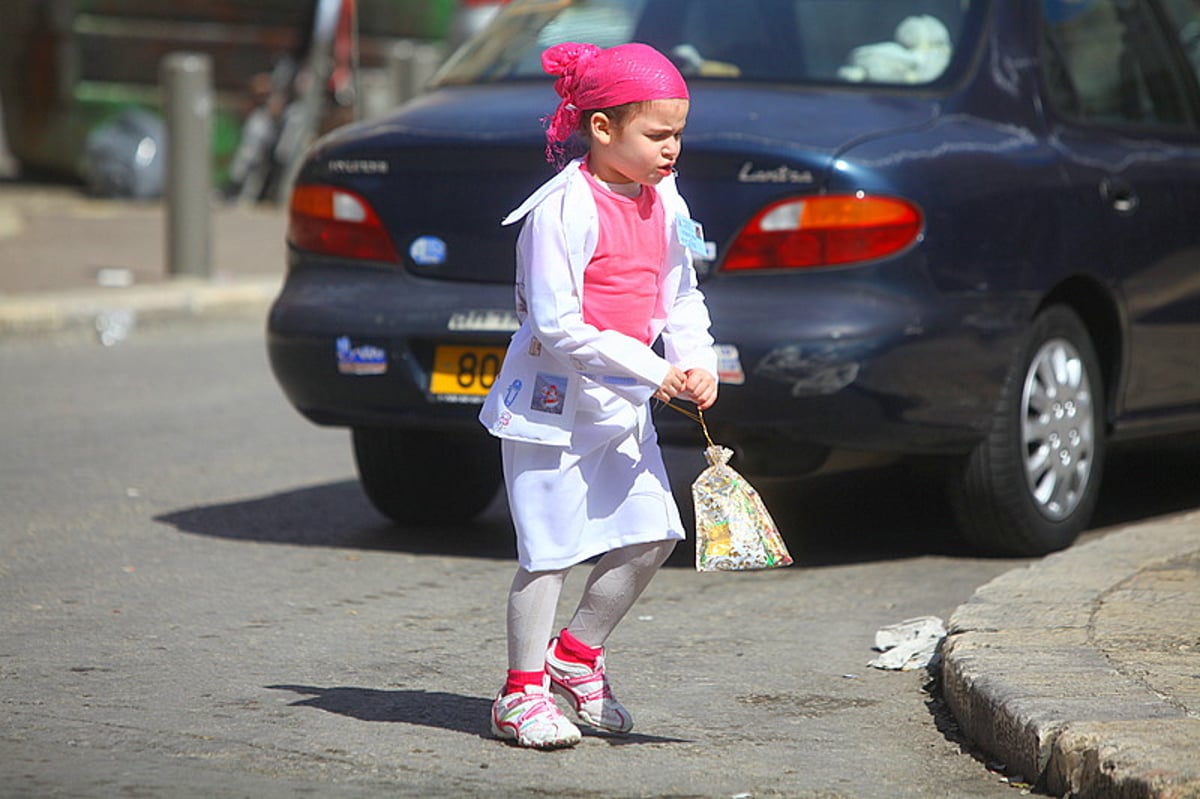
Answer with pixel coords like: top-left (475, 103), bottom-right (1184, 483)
top-left (155, 441), bottom-right (1200, 569)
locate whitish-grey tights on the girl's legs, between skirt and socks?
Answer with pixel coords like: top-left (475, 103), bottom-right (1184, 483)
top-left (509, 540), bottom-right (676, 672)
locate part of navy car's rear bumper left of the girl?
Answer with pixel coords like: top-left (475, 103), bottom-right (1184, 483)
top-left (266, 257), bottom-right (516, 432)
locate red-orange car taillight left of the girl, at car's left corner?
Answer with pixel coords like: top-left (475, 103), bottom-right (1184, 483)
top-left (288, 186), bottom-right (400, 262)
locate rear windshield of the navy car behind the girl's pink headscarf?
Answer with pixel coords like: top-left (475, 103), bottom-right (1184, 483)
top-left (437, 0), bottom-right (985, 86)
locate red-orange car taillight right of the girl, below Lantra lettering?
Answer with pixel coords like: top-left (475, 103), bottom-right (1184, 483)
top-left (722, 193), bottom-right (923, 270)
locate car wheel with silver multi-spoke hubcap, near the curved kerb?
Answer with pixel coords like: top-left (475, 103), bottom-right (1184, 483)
top-left (952, 306), bottom-right (1104, 557)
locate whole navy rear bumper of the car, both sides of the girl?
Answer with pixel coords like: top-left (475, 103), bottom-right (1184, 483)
top-left (268, 251), bottom-right (1026, 473)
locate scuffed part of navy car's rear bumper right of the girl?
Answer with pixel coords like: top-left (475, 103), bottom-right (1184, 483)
top-left (691, 276), bottom-right (1026, 453)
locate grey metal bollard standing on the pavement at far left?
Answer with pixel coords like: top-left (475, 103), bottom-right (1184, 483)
top-left (160, 53), bottom-right (212, 277)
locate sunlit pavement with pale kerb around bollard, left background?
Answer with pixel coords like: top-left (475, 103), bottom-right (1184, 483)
top-left (0, 181), bottom-right (287, 337)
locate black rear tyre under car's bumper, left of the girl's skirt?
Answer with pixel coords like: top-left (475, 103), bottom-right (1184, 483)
top-left (353, 427), bottom-right (500, 524)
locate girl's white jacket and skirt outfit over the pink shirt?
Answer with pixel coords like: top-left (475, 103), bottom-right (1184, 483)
top-left (480, 164), bottom-right (716, 572)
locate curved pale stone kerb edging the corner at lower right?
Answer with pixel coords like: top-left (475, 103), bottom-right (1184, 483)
top-left (942, 513), bottom-right (1200, 799)
